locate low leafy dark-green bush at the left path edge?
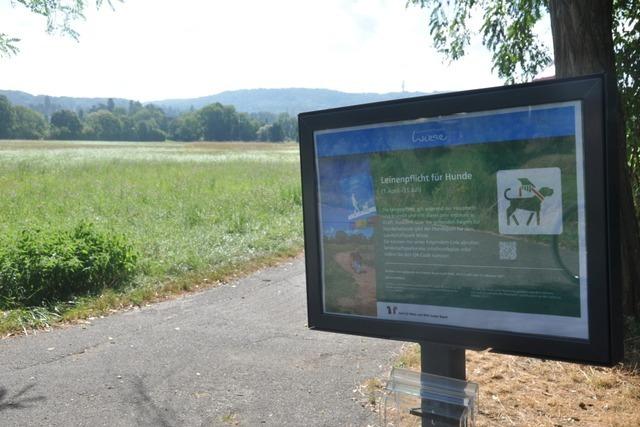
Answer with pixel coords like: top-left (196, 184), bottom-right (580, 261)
top-left (0, 222), bottom-right (138, 309)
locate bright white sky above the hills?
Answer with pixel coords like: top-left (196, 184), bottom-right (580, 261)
top-left (0, 0), bottom-right (552, 102)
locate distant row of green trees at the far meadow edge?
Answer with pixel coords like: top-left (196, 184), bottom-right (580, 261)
top-left (0, 95), bottom-right (298, 142)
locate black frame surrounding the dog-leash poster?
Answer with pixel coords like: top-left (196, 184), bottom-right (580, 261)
top-left (299, 75), bottom-right (623, 366)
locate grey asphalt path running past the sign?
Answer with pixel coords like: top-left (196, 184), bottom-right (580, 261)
top-left (0, 259), bottom-right (400, 426)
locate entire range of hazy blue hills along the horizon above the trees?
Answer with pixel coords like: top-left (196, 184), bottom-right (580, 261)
top-left (0, 88), bottom-right (426, 115)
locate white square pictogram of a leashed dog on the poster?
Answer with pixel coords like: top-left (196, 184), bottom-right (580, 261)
top-left (497, 168), bottom-right (562, 235)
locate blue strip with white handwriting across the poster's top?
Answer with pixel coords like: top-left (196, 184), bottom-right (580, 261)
top-left (315, 106), bottom-right (575, 157)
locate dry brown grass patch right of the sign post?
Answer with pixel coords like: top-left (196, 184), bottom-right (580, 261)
top-left (467, 351), bottom-right (640, 427)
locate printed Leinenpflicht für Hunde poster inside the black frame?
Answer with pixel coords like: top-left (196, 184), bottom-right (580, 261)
top-left (315, 102), bottom-right (589, 339)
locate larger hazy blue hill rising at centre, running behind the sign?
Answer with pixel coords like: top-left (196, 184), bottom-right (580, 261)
top-left (153, 88), bottom-right (426, 114)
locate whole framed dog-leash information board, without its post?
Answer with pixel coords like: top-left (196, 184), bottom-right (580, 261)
top-left (300, 76), bottom-right (620, 364)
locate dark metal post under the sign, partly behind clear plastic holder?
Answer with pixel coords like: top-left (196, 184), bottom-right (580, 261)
top-left (420, 342), bottom-right (466, 427)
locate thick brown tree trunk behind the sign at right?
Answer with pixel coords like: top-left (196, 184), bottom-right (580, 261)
top-left (549, 0), bottom-right (640, 318)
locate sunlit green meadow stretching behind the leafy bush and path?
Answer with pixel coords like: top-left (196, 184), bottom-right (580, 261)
top-left (0, 141), bottom-right (302, 332)
